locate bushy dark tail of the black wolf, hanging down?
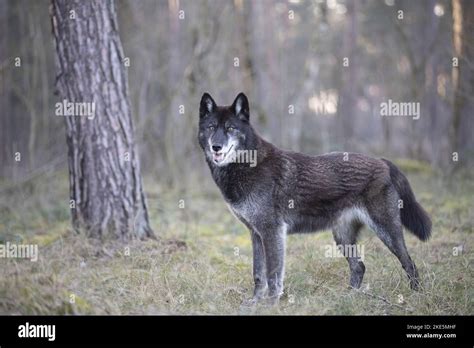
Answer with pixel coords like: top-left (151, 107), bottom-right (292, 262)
top-left (382, 158), bottom-right (431, 241)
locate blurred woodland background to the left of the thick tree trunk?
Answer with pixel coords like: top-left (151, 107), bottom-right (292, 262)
top-left (0, 0), bottom-right (60, 179)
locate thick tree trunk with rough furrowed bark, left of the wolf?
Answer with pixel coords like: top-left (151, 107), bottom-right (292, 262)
top-left (51, 0), bottom-right (153, 239)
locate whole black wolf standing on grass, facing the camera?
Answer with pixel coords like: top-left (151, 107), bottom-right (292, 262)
top-left (198, 93), bottom-right (431, 302)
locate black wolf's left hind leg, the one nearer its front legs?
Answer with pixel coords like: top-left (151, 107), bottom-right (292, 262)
top-left (333, 221), bottom-right (365, 289)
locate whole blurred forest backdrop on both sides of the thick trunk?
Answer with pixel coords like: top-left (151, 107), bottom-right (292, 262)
top-left (0, 0), bottom-right (474, 188)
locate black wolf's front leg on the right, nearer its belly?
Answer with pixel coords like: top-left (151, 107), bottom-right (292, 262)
top-left (262, 227), bottom-right (286, 303)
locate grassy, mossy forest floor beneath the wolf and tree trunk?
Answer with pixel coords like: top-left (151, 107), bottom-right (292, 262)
top-left (0, 163), bottom-right (474, 315)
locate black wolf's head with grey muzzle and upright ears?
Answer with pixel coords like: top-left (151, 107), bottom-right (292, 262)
top-left (198, 93), bottom-right (254, 167)
